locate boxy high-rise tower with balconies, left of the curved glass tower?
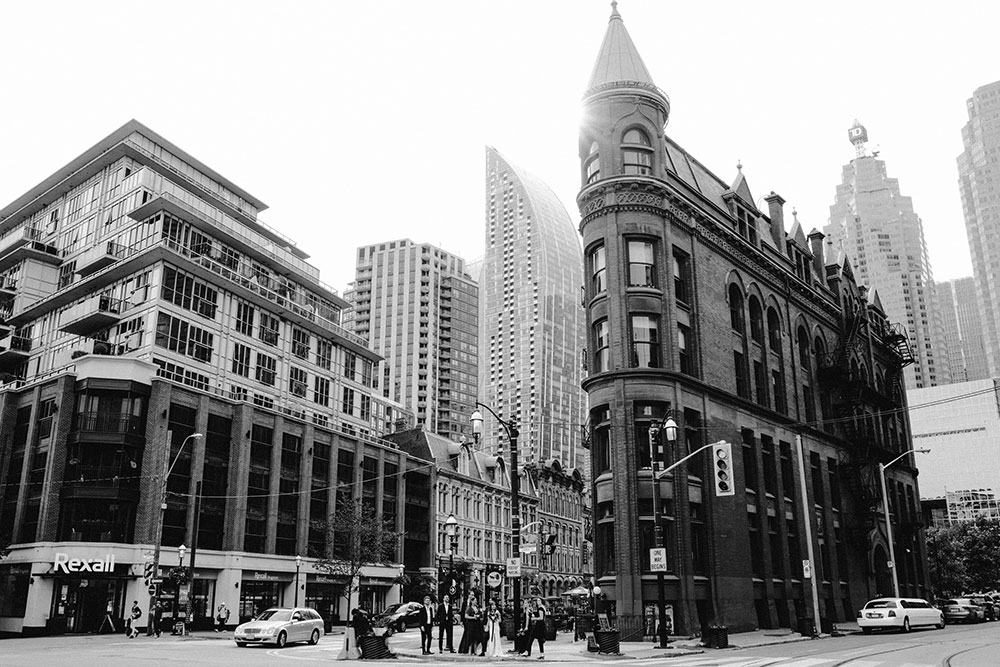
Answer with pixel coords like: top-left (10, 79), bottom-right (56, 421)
top-left (347, 239), bottom-right (479, 440)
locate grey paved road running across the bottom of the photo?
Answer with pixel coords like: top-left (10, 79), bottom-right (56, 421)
top-left (0, 623), bottom-right (1000, 667)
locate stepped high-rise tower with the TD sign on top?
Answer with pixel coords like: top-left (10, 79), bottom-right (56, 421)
top-left (824, 121), bottom-right (951, 389)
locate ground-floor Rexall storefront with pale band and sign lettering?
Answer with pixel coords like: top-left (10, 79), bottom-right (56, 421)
top-left (0, 542), bottom-right (400, 636)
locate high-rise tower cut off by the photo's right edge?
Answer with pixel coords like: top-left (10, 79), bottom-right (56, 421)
top-left (958, 81), bottom-right (1000, 377)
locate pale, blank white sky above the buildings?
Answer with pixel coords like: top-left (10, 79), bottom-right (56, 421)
top-left (0, 0), bottom-right (1000, 291)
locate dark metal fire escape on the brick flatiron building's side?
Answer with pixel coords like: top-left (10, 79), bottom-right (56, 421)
top-left (819, 307), bottom-right (913, 550)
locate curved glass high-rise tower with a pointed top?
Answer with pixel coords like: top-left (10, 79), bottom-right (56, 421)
top-left (479, 147), bottom-right (587, 470)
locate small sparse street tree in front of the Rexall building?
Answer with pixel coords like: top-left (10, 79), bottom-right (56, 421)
top-left (313, 497), bottom-right (402, 613)
